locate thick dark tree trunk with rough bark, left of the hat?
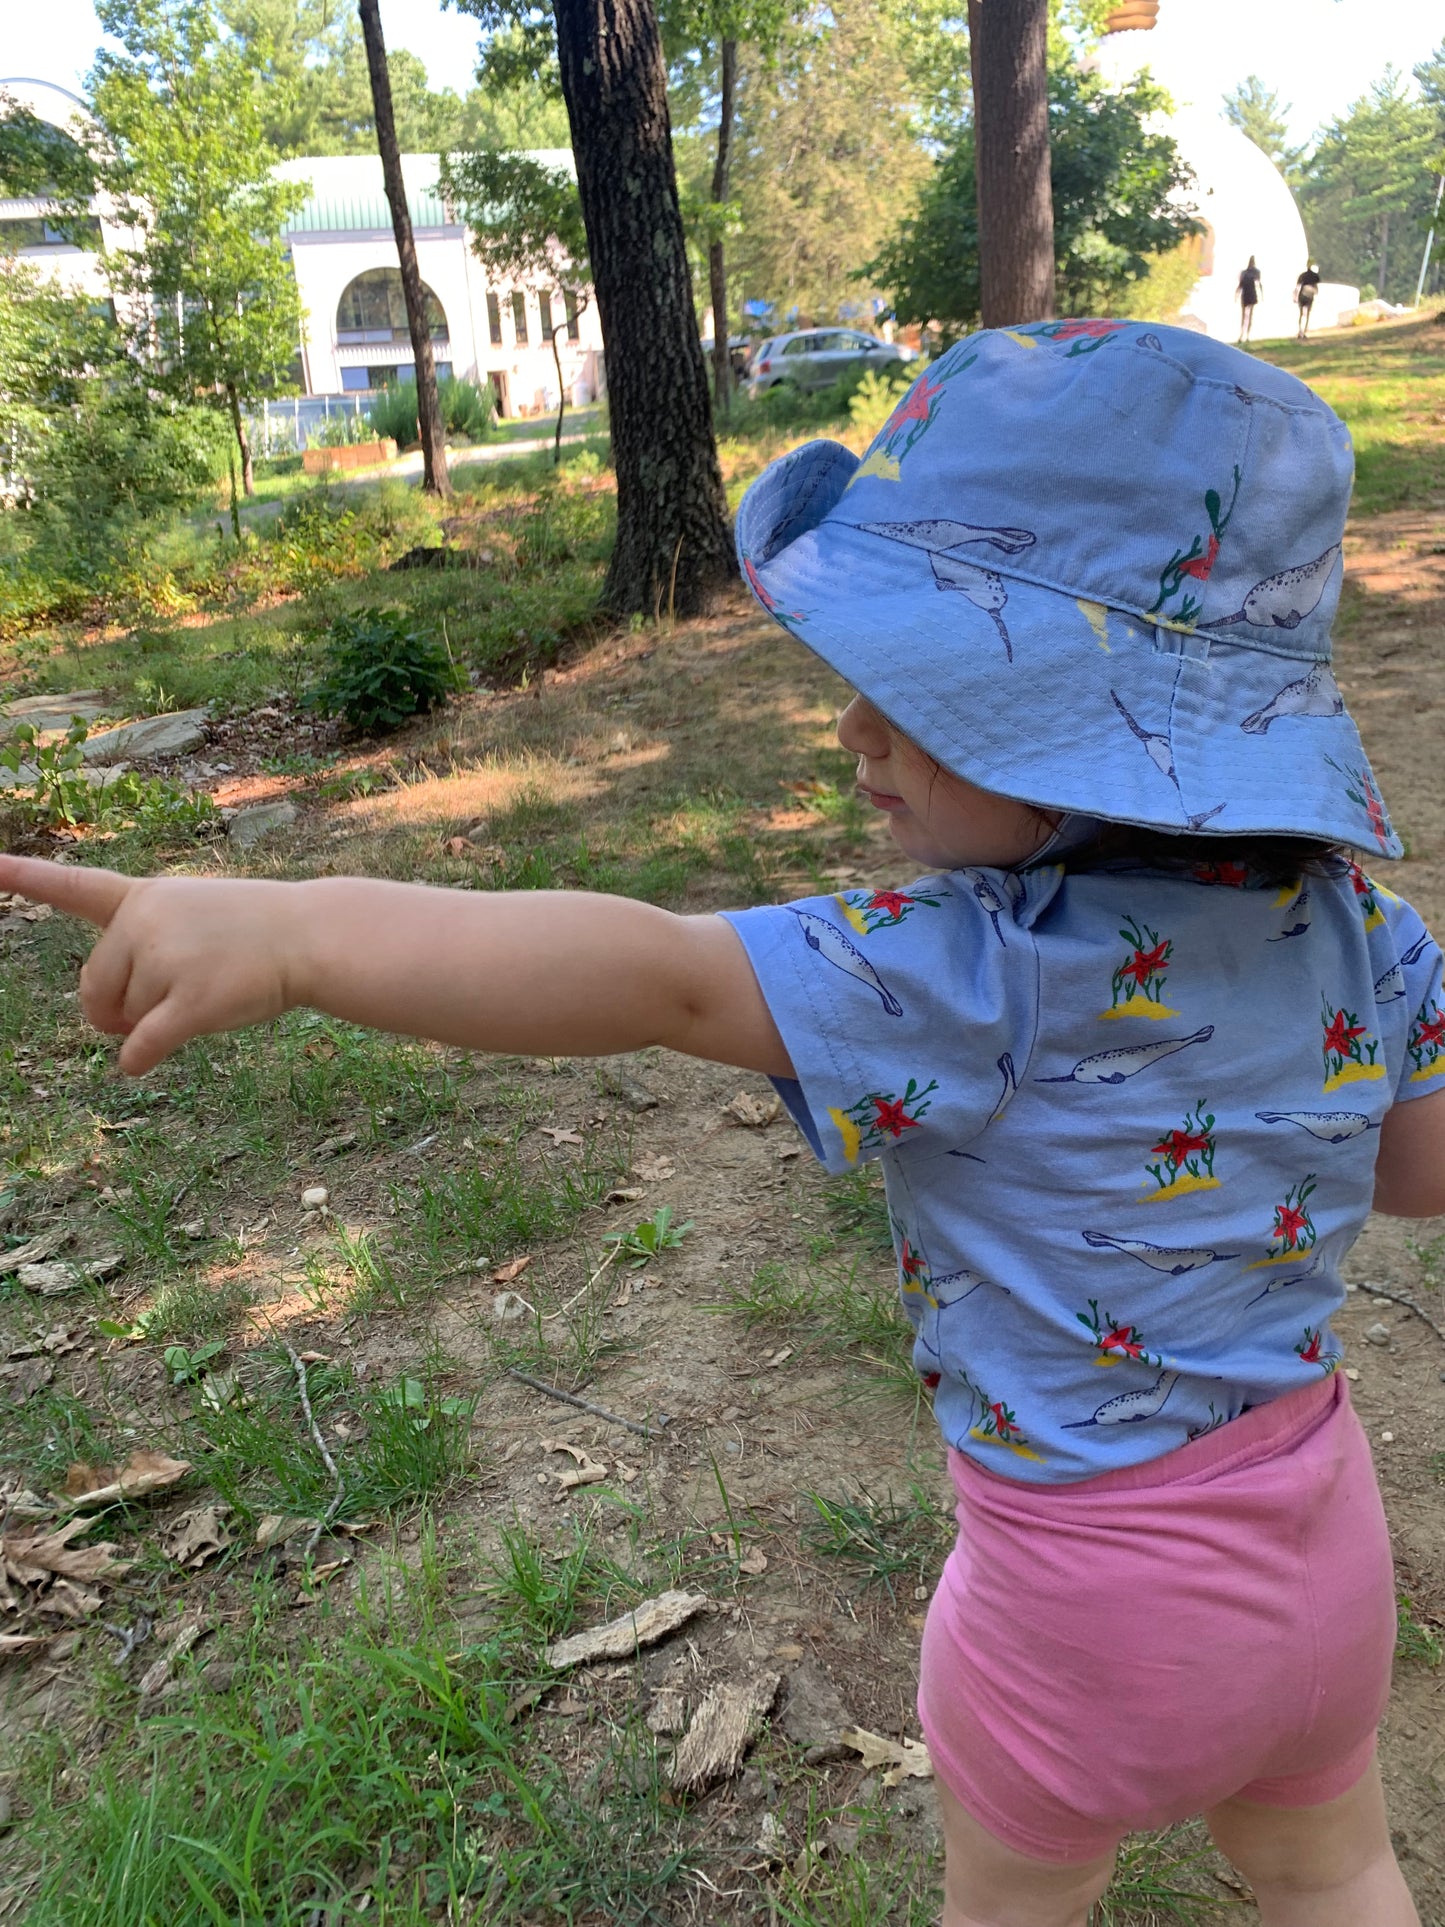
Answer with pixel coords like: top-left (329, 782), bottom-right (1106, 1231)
top-left (553, 0), bottom-right (736, 617)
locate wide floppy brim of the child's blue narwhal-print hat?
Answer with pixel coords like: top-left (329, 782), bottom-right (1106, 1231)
top-left (738, 441), bottom-right (1403, 858)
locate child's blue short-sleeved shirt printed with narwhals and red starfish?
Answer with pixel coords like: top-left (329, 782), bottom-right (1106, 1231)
top-left (728, 861), bottom-right (1445, 1484)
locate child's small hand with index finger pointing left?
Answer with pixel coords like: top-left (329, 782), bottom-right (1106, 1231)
top-left (0, 856), bottom-right (304, 1077)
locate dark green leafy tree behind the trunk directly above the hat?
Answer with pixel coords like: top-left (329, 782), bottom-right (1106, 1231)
top-left (867, 64), bottom-right (1195, 337)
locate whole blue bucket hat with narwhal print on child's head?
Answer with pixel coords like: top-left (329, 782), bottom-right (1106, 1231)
top-left (738, 320), bottom-right (1401, 856)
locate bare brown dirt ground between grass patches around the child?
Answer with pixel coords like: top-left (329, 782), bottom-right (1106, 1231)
top-left (8, 489), bottom-right (1445, 1927)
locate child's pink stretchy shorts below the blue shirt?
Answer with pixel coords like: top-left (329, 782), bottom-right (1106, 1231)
top-left (919, 1374), bottom-right (1395, 1863)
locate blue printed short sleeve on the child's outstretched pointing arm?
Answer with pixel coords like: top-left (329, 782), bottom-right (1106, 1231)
top-left (724, 869), bottom-right (1058, 1172)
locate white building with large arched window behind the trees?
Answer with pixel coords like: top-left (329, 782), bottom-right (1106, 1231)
top-left (0, 77), bottom-right (607, 414)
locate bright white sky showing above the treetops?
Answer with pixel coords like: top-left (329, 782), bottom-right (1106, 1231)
top-left (0, 0), bottom-right (1445, 143)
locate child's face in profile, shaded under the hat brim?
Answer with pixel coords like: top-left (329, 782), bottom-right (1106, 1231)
top-left (838, 696), bottom-right (1058, 869)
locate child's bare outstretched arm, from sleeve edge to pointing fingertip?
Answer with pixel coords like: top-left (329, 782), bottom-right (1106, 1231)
top-left (0, 856), bottom-right (792, 1077)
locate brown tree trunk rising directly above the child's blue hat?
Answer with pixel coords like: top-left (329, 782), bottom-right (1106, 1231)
top-left (969, 0), bottom-right (1054, 328)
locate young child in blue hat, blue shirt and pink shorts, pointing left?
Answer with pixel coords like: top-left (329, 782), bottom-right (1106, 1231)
top-left (0, 322), bottom-right (1445, 1927)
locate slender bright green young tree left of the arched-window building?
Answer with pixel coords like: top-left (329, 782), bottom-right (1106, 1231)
top-left (81, 0), bottom-right (304, 495)
